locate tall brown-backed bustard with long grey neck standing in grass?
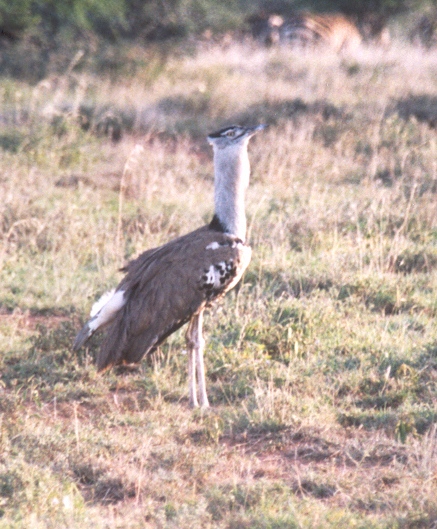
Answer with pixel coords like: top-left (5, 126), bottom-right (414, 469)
top-left (73, 125), bottom-right (265, 408)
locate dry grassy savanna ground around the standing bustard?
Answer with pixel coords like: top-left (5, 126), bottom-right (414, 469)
top-left (0, 35), bottom-right (437, 529)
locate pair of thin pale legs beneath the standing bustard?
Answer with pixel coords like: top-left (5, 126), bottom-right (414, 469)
top-left (186, 311), bottom-right (209, 408)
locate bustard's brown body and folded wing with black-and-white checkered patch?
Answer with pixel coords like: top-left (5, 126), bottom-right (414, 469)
top-left (97, 229), bottom-right (251, 370)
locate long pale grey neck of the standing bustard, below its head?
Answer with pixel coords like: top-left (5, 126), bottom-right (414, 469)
top-left (214, 142), bottom-right (250, 241)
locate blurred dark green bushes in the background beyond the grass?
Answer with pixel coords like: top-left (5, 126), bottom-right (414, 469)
top-left (0, 0), bottom-right (437, 80)
